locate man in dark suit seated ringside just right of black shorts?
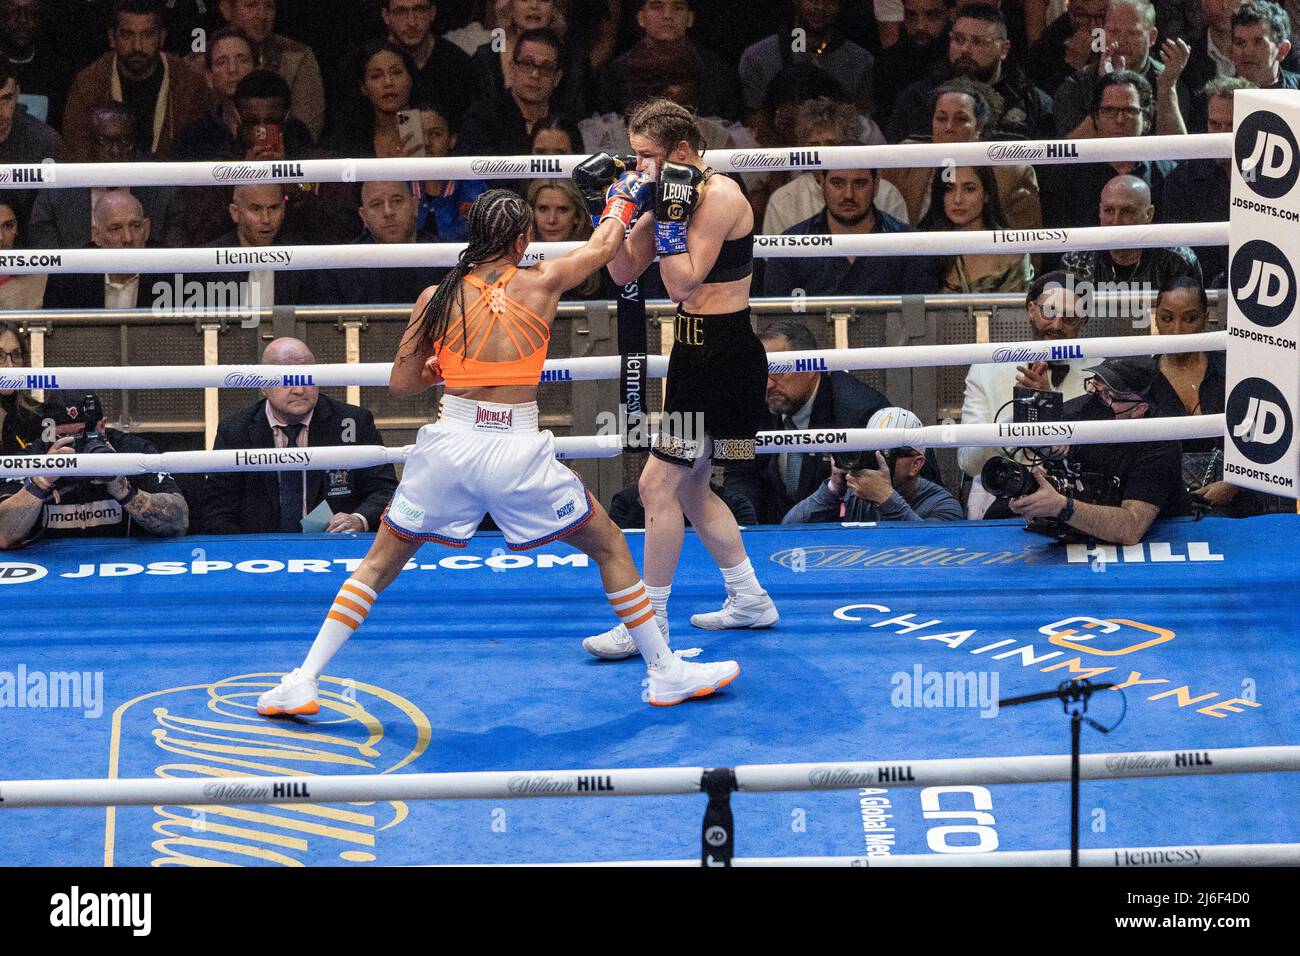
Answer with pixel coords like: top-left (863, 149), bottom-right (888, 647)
top-left (723, 319), bottom-right (891, 524)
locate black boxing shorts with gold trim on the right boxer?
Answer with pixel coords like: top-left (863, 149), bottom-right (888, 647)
top-left (651, 306), bottom-right (767, 467)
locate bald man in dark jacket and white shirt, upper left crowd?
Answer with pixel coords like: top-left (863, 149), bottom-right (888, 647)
top-left (44, 190), bottom-right (173, 308)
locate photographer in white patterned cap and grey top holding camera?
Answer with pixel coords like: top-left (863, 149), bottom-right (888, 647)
top-left (781, 407), bottom-right (966, 524)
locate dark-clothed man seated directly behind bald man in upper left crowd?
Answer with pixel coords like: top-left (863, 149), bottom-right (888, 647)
top-left (29, 103), bottom-right (187, 248)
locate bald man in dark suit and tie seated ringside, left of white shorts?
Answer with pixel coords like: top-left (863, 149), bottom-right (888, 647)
top-left (203, 337), bottom-right (398, 535)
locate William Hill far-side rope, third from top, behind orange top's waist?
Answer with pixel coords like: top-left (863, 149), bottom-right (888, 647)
top-left (0, 332), bottom-right (1227, 389)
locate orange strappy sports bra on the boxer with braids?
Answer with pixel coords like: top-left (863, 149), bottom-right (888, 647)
top-left (434, 265), bottom-right (551, 389)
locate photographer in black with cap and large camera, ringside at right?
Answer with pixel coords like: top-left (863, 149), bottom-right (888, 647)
top-left (1003, 359), bottom-right (1184, 545)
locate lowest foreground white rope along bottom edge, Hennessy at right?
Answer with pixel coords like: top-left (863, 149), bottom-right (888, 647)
top-left (543, 843), bottom-right (1300, 869)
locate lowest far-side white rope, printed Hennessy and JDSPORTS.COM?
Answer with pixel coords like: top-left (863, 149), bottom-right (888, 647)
top-left (0, 415), bottom-right (1227, 479)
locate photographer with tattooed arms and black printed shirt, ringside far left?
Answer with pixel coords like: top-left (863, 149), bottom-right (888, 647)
top-left (0, 392), bottom-right (190, 550)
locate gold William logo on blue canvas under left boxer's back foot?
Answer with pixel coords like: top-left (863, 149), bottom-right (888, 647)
top-left (104, 674), bottom-right (433, 866)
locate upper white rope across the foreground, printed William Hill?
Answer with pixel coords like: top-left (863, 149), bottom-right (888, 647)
top-left (0, 747), bottom-right (1300, 809)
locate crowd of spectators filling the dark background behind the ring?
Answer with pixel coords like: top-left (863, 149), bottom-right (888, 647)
top-left (0, 0), bottom-right (1300, 542)
